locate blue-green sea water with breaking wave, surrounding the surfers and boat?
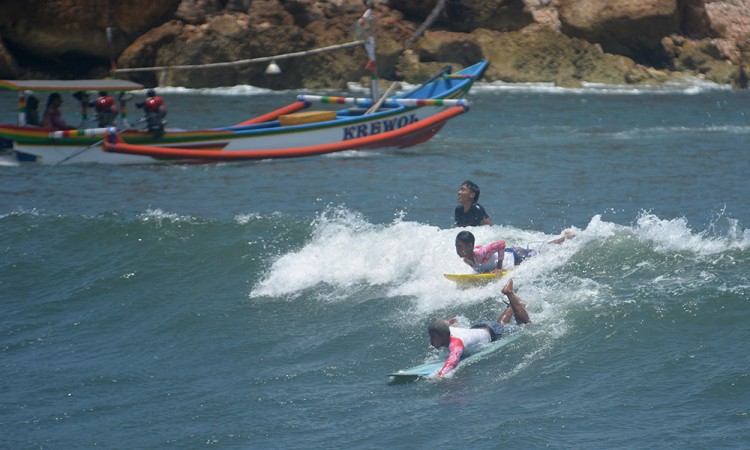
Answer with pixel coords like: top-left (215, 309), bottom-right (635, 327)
top-left (0, 79), bottom-right (750, 449)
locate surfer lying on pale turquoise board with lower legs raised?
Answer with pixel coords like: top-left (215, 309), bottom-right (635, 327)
top-left (427, 278), bottom-right (531, 377)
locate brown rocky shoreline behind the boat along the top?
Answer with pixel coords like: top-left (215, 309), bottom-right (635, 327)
top-left (0, 0), bottom-right (750, 89)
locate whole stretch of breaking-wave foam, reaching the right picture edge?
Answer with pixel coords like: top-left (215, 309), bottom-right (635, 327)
top-left (250, 208), bottom-right (750, 334)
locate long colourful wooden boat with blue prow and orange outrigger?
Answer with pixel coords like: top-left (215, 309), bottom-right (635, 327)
top-left (0, 61), bottom-right (488, 164)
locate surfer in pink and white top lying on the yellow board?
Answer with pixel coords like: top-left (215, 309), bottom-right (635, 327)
top-left (456, 230), bottom-right (575, 274)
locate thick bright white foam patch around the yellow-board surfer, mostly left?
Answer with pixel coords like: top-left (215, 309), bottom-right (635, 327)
top-left (251, 209), bottom-right (588, 304)
